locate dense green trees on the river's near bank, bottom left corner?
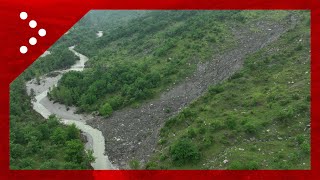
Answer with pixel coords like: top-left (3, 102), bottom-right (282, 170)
top-left (10, 75), bottom-right (94, 169)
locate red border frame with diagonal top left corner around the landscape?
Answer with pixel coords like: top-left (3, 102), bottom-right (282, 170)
top-left (0, 0), bottom-right (320, 179)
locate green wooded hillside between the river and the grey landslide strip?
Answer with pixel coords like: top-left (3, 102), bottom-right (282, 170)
top-left (50, 11), bottom-right (289, 116)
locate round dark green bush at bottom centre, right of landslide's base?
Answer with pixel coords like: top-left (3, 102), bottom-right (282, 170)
top-left (170, 139), bottom-right (200, 165)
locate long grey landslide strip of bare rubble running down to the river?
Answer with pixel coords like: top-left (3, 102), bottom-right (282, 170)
top-left (88, 17), bottom-right (297, 169)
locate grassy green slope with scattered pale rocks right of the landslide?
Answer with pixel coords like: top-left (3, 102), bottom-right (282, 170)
top-left (146, 12), bottom-right (310, 169)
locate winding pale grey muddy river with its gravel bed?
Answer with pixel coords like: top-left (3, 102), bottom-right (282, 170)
top-left (26, 46), bottom-right (114, 169)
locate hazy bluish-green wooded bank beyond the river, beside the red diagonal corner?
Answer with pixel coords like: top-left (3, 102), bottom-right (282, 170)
top-left (24, 11), bottom-right (144, 79)
